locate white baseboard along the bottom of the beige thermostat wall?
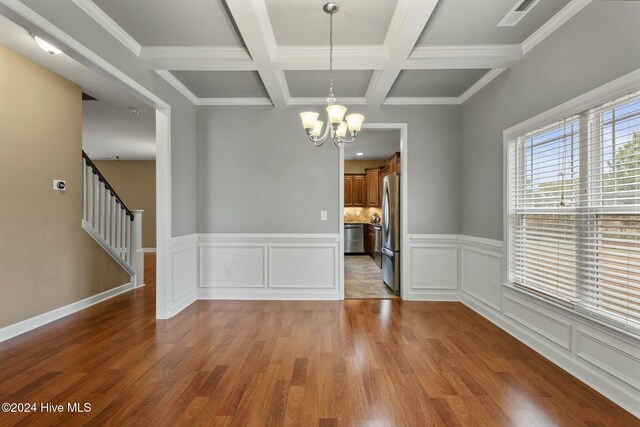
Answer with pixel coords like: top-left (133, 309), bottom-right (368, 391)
top-left (0, 282), bottom-right (133, 342)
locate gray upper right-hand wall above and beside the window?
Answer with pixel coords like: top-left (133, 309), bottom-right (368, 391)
top-left (460, 1), bottom-right (640, 240)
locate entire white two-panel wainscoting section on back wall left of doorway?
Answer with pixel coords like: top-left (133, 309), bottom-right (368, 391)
top-left (198, 234), bottom-right (341, 300)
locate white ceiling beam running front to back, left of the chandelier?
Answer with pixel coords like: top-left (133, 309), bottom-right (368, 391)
top-left (222, 0), bottom-right (291, 108)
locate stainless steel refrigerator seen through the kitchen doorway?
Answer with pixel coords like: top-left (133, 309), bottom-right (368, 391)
top-left (382, 172), bottom-right (401, 295)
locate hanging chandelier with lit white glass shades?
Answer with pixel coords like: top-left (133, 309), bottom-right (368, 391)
top-left (300, 3), bottom-right (364, 148)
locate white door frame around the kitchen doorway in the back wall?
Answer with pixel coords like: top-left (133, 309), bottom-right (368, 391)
top-left (338, 123), bottom-right (409, 300)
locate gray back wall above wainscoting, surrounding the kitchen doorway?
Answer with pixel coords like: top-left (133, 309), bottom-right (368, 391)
top-left (197, 106), bottom-right (460, 233)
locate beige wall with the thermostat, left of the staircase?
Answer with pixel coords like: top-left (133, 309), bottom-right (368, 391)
top-left (0, 46), bottom-right (130, 327)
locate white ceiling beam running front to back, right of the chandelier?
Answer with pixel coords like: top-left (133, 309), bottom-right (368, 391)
top-left (365, 0), bottom-right (438, 107)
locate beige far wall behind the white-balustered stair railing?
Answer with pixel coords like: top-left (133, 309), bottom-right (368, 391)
top-left (94, 160), bottom-right (156, 248)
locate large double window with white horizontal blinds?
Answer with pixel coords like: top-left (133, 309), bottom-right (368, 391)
top-left (508, 92), bottom-right (640, 332)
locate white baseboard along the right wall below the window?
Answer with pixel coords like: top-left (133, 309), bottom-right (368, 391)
top-left (461, 292), bottom-right (640, 418)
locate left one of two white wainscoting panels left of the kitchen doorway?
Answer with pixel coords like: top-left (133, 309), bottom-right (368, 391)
top-left (200, 245), bottom-right (266, 288)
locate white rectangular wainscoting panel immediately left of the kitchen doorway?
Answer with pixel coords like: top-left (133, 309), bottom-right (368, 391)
top-left (269, 245), bottom-right (338, 289)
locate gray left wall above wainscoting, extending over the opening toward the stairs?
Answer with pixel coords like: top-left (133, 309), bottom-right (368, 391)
top-left (5, 0), bottom-right (196, 236)
